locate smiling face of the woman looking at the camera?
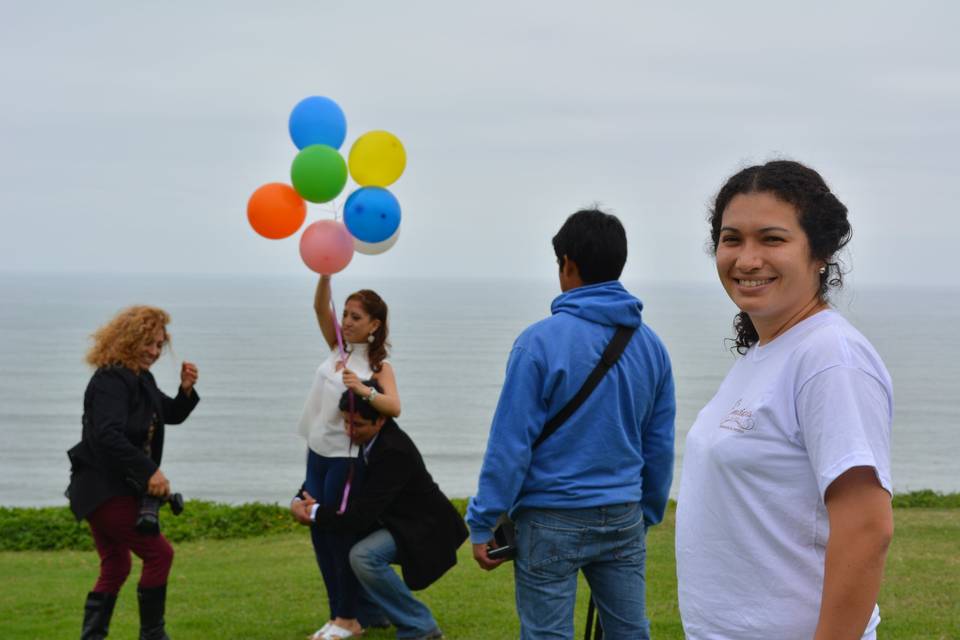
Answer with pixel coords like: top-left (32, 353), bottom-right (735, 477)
top-left (716, 192), bottom-right (823, 336)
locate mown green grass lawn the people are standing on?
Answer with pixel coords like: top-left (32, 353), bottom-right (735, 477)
top-left (0, 507), bottom-right (960, 640)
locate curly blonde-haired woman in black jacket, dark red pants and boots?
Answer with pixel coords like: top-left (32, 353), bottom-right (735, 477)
top-left (67, 306), bottom-right (199, 640)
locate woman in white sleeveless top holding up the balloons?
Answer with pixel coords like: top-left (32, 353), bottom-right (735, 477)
top-left (291, 275), bottom-right (400, 640)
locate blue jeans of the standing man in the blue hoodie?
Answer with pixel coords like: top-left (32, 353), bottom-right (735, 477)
top-left (514, 503), bottom-right (650, 640)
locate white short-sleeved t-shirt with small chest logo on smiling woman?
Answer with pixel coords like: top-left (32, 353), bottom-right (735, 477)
top-left (676, 310), bottom-right (893, 640)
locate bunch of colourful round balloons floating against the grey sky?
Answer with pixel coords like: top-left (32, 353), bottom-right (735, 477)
top-left (247, 96), bottom-right (406, 275)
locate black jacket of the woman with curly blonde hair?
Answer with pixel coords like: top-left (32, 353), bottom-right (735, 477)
top-left (67, 366), bottom-right (200, 520)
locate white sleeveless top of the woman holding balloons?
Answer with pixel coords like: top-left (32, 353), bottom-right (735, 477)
top-left (299, 342), bottom-right (387, 458)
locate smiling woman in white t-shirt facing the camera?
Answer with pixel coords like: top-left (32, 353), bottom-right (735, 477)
top-left (676, 161), bottom-right (893, 640)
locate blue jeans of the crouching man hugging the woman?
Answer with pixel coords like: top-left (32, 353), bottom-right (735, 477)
top-left (350, 529), bottom-right (437, 638)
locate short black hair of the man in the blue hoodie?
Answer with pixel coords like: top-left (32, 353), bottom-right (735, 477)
top-left (553, 209), bottom-right (627, 284)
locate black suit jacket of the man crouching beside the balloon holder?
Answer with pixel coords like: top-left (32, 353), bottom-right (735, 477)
top-left (316, 420), bottom-right (467, 589)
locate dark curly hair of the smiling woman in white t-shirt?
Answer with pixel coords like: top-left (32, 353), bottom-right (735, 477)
top-left (708, 160), bottom-right (853, 355)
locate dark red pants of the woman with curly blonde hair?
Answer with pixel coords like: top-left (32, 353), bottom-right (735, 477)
top-left (87, 496), bottom-right (173, 594)
